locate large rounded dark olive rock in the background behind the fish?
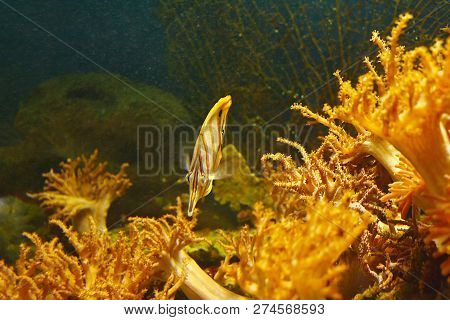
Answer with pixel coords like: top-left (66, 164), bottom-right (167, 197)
top-left (0, 73), bottom-right (190, 219)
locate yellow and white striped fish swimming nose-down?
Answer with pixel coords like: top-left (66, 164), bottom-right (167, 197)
top-left (186, 96), bottom-right (232, 217)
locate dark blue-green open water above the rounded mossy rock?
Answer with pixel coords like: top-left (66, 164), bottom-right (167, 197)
top-left (0, 0), bottom-right (169, 123)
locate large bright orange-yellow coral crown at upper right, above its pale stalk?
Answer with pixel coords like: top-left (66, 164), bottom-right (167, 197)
top-left (329, 14), bottom-right (450, 205)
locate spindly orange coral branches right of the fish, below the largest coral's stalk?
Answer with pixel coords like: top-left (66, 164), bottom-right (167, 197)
top-left (262, 138), bottom-right (390, 220)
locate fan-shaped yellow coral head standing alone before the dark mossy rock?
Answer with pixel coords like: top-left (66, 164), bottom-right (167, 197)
top-left (30, 150), bottom-right (131, 232)
